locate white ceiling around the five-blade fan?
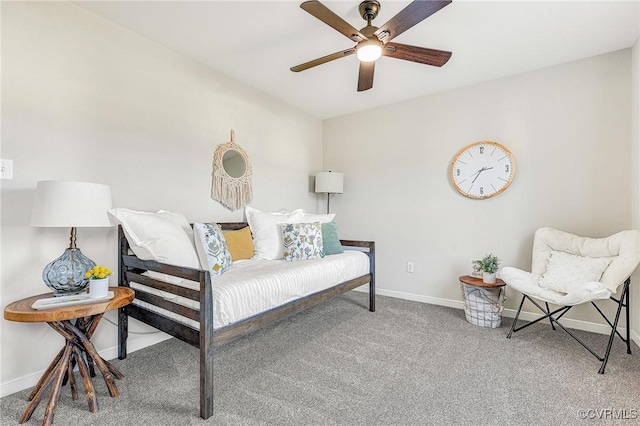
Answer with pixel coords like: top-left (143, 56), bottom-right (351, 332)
top-left (74, 0), bottom-right (640, 118)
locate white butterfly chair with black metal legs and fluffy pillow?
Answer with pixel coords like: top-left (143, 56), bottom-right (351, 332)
top-left (500, 228), bottom-right (640, 374)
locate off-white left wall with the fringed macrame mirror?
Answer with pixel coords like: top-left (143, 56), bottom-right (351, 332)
top-left (0, 2), bottom-right (323, 395)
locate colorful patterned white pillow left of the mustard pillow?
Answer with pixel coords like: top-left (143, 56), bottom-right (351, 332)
top-left (193, 223), bottom-right (232, 277)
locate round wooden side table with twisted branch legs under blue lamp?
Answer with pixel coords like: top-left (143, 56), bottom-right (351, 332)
top-left (4, 287), bottom-right (135, 425)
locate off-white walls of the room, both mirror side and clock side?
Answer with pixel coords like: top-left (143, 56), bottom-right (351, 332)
top-left (0, 2), bottom-right (640, 395)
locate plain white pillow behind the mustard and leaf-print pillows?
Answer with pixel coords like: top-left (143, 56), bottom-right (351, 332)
top-left (244, 207), bottom-right (304, 260)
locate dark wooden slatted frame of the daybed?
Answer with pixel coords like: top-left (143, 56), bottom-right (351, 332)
top-left (118, 222), bottom-right (375, 419)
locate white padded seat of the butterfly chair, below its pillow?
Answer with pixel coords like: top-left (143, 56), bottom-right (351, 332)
top-left (500, 266), bottom-right (611, 306)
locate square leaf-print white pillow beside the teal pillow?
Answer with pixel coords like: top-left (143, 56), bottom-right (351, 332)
top-left (282, 222), bottom-right (324, 262)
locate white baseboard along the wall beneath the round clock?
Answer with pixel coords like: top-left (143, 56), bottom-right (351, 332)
top-left (356, 286), bottom-right (640, 346)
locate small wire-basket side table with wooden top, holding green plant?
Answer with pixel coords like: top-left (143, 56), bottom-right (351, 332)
top-left (458, 275), bottom-right (505, 328)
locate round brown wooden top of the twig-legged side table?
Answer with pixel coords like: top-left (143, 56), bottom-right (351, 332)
top-left (4, 287), bottom-right (135, 322)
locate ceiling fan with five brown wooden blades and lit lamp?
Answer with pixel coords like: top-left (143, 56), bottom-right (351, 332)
top-left (291, 0), bottom-right (451, 92)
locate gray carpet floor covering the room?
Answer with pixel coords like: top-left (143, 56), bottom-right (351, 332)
top-left (0, 292), bottom-right (640, 426)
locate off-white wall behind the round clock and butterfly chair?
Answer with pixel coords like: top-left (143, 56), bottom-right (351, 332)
top-left (323, 49), bottom-right (640, 336)
